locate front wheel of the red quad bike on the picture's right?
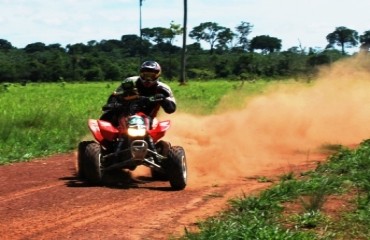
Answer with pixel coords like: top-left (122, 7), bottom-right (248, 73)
top-left (166, 146), bottom-right (188, 190)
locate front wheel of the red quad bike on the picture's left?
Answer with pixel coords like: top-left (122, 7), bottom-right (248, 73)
top-left (82, 142), bottom-right (103, 184)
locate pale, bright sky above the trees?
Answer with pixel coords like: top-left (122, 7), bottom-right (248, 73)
top-left (0, 0), bottom-right (370, 50)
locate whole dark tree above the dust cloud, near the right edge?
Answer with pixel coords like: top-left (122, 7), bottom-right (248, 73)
top-left (326, 27), bottom-right (358, 55)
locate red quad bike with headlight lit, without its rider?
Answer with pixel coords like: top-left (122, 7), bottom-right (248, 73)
top-left (77, 96), bottom-right (187, 190)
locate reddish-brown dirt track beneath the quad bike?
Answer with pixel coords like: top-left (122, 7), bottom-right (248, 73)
top-left (0, 153), bottom-right (323, 240)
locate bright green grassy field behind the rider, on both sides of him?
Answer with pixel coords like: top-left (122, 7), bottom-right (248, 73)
top-left (0, 81), bottom-right (274, 164)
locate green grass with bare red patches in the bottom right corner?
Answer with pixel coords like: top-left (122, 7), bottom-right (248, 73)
top-left (181, 140), bottom-right (370, 240)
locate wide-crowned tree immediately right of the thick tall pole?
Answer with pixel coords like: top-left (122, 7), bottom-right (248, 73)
top-left (189, 22), bottom-right (232, 54)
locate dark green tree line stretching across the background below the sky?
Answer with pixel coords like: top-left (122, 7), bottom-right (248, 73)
top-left (0, 22), bottom-right (370, 82)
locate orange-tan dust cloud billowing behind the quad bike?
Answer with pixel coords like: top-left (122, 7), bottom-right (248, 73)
top-left (166, 55), bottom-right (370, 185)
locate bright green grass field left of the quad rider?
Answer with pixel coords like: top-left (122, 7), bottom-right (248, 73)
top-left (0, 84), bottom-right (111, 164)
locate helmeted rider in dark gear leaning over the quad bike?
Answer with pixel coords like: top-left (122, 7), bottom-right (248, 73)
top-left (100, 61), bottom-right (176, 126)
